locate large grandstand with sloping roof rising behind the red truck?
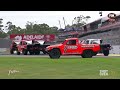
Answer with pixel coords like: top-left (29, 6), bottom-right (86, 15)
top-left (58, 15), bottom-right (120, 45)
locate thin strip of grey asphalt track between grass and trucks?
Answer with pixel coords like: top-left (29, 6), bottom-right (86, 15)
top-left (0, 55), bottom-right (120, 58)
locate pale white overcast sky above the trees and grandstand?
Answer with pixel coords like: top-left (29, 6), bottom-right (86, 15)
top-left (0, 11), bottom-right (120, 28)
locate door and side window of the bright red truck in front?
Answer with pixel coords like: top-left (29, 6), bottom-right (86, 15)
top-left (64, 40), bottom-right (78, 54)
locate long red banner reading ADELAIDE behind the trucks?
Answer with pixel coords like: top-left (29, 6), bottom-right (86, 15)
top-left (10, 34), bottom-right (55, 41)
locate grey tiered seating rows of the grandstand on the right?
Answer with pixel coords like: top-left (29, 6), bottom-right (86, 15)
top-left (59, 15), bottom-right (120, 45)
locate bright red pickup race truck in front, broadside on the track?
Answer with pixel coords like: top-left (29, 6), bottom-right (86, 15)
top-left (46, 38), bottom-right (108, 59)
